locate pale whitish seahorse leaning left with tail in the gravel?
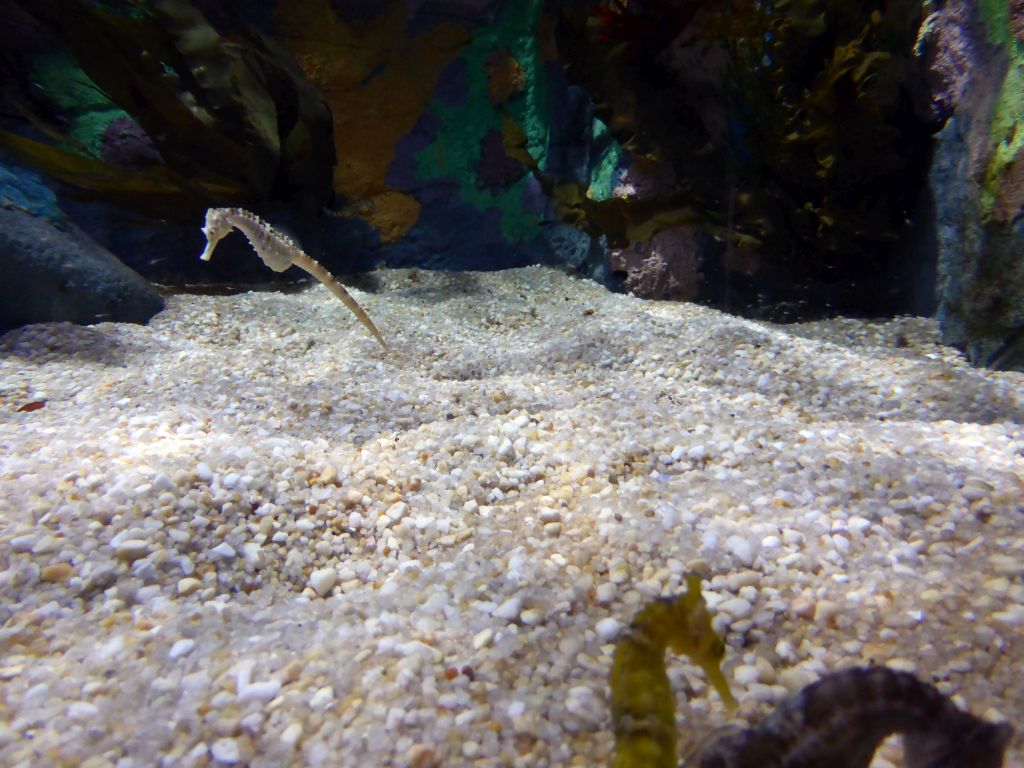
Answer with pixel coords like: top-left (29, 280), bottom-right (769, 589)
top-left (200, 208), bottom-right (387, 349)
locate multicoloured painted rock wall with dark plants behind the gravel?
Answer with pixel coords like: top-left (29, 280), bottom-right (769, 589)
top-left (0, 0), bottom-right (1024, 368)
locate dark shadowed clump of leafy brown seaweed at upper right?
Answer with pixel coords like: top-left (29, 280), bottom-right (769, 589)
top-left (557, 0), bottom-right (941, 290)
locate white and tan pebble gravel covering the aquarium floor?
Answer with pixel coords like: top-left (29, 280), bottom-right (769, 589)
top-left (0, 267), bottom-right (1024, 768)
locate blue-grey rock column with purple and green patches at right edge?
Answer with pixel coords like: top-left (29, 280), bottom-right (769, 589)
top-left (921, 0), bottom-right (1024, 371)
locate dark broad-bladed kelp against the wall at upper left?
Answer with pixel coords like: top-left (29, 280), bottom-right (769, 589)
top-left (0, 0), bottom-right (335, 219)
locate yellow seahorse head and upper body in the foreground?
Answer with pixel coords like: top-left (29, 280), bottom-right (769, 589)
top-left (609, 575), bottom-right (736, 768)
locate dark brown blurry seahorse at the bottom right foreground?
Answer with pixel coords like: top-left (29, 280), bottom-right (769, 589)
top-left (684, 667), bottom-right (1014, 768)
